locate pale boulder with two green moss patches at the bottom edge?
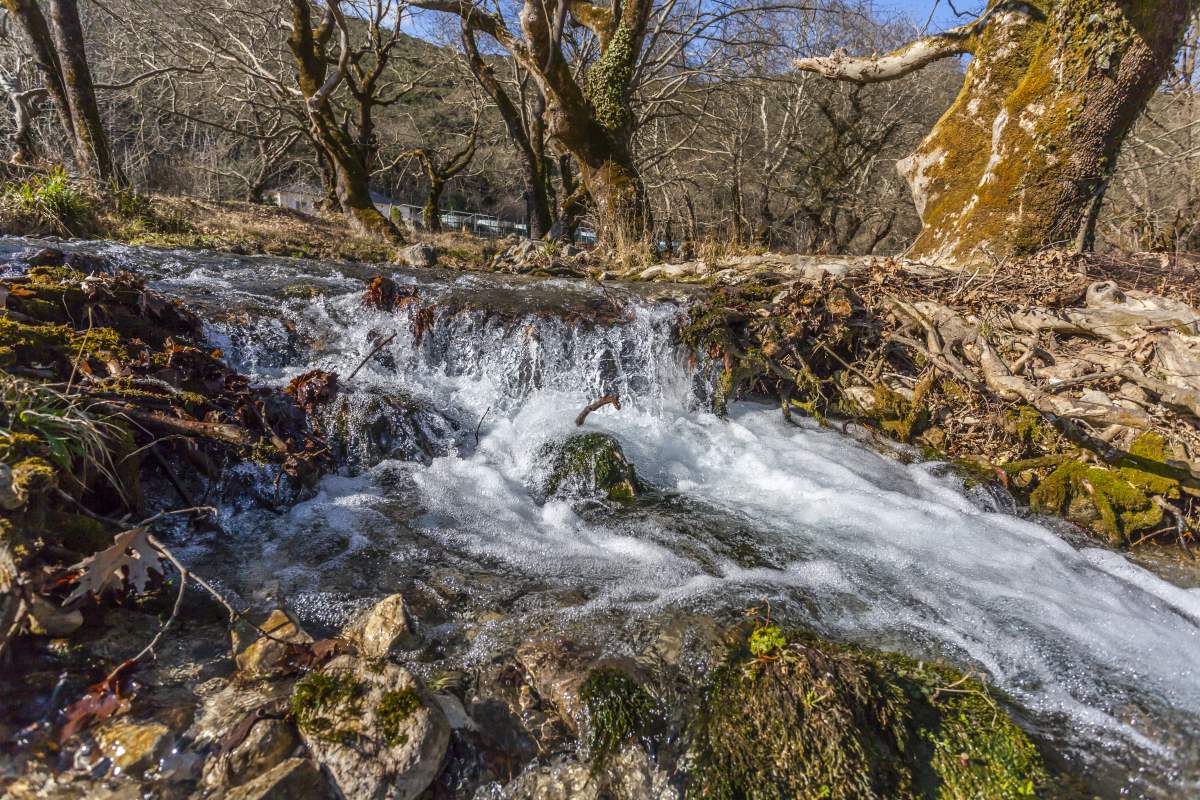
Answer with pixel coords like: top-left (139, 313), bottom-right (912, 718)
top-left (292, 656), bottom-right (450, 800)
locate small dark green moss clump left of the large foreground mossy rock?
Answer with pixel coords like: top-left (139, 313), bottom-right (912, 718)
top-left (580, 667), bottom-right (658, 765)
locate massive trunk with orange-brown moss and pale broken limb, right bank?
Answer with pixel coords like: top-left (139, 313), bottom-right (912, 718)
top-left (797, 0), bottom-right (1198, 264)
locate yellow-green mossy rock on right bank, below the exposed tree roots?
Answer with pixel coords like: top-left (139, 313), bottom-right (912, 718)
top-left (1030, 461), bottom-right (1163, 545)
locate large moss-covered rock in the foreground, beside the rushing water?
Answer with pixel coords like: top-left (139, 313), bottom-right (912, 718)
top-left (685, 628), bottom-right (1050, 800)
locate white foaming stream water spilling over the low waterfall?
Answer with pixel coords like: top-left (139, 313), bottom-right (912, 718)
top-left (6, 242), bottom-right (1200, 798)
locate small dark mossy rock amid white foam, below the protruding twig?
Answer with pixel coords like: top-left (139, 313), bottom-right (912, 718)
top-left (541, 433), bottom-right (638, 503)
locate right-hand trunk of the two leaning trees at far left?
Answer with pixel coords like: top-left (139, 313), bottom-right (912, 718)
top-left (49, 0), bottom-right (125, 184)
